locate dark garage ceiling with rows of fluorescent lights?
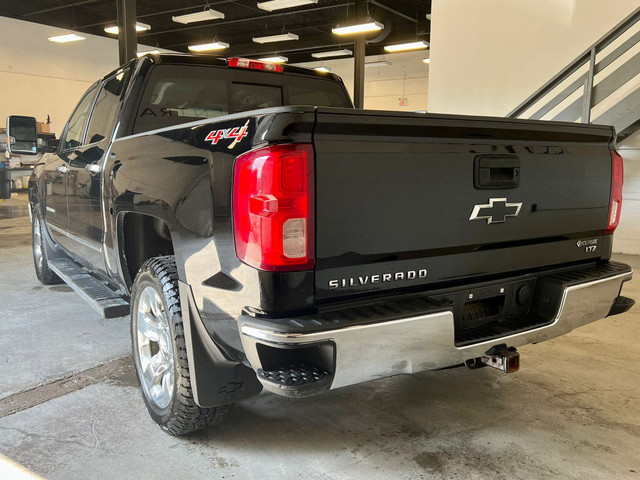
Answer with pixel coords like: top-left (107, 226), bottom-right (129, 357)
top-left (0, 0), bottom-right (431, 63)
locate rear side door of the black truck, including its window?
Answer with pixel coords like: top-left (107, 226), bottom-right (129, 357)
top-left (67, 70), bottom-right (128, 270)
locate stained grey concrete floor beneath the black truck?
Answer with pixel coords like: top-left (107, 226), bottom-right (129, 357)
top-left (0, 193), bottom-right (640, 480)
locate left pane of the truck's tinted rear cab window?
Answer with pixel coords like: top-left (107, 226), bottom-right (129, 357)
top-left (133, 65), bottom-right (229, 133)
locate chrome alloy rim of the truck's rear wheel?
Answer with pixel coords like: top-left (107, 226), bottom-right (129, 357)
top-left (136, 287), bottom-right (175, 408)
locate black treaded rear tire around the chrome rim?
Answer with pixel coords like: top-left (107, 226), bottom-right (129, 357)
top-left (131, 256), bottom-right (228, 435)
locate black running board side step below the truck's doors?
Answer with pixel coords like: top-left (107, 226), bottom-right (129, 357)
top-left (49, 257), bottom-right (129, 318)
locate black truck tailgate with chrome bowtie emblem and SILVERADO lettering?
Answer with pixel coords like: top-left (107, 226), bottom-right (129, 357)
top-left (314, 109), bottom-right (613, 299)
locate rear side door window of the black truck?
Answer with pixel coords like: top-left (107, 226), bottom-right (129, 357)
top-left (87, 69), bottom-right (129, 143)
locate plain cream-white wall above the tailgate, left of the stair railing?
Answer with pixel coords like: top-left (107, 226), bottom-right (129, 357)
top-left (429, 0), bottom-right (640, 116)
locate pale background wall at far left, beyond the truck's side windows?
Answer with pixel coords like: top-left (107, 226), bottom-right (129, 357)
top-left (0, 17), bottom-right (169, 135)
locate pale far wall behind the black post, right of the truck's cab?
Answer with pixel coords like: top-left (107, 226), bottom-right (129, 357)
top-left (299, 50), bottom-right (429, 111)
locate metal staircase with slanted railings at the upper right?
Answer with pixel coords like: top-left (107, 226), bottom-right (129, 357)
top-left (507, 7), bottom-right (640, 142)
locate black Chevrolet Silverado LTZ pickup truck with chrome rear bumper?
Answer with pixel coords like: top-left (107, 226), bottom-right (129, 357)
top-left (18, 55), bottom-right (633, 435)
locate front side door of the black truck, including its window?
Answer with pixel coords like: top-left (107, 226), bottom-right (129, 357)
top-left (42, 85), bottom-right (98, 248)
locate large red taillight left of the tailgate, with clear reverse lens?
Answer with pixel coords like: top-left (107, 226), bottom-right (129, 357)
top-left (233, 144), bottom-right (314, 271)
